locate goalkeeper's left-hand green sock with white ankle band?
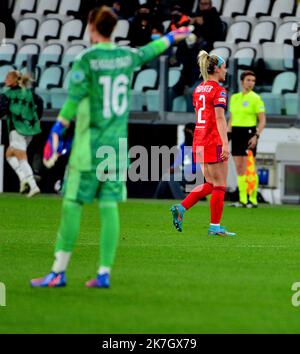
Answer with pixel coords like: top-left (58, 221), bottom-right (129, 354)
top-left (52, 199), bottom-right (82, 273)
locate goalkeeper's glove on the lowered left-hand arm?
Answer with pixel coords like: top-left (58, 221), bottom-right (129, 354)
top-left (43, 121), bottom-right (65, 168)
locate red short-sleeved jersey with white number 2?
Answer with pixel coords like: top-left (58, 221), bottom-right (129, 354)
top-left (193, 80), bottom-right (227, 150)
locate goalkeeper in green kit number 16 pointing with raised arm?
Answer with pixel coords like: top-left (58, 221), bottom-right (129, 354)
top-left (31, 6), bottom-right (190, 288)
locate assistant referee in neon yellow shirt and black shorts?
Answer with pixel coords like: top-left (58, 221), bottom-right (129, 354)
top-left (228, 70), bottom-right (266, 208)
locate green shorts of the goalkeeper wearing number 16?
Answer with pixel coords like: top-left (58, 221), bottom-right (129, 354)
top-left (63, 168), bottom-right (127, 203)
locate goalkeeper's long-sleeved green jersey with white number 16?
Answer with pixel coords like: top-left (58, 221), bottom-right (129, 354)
top-left (60, 39), bottom-right (169, 171)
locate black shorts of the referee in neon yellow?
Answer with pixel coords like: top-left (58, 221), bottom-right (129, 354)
top-left (231, 127), bottom-right (256, 156)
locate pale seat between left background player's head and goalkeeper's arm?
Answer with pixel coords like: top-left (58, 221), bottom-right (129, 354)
top-left (36, 66), bottom-right (62, 108)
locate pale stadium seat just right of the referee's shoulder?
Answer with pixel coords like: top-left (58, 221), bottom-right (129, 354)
top-left (261, 72), bottom-right (297, 114)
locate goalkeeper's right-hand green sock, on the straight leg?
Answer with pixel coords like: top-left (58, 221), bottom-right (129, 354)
top-left (98, 202), bottom-right (120, 274)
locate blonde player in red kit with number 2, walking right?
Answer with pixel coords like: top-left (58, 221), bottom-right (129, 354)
top-left (171, 50), bottom-right (235, 236)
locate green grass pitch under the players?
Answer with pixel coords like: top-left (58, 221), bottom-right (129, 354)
top-left (0, 194), bottom-right (300, 333)
